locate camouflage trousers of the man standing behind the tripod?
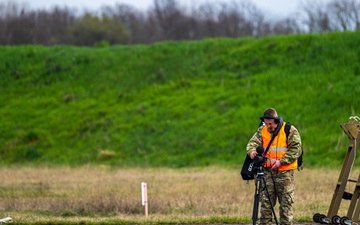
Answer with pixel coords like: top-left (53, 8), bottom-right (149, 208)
top-left (260, 169), bottom-right (295, 225)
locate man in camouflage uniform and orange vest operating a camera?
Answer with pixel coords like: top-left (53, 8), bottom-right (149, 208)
top-left (246, 108), bottom-right (302, 225)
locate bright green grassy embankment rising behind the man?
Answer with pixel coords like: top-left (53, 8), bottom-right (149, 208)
top-left (0, 32), bottom-right (360, 167)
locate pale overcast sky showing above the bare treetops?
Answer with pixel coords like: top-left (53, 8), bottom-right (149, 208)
top-left (7, 0), bottom-right (330, 16)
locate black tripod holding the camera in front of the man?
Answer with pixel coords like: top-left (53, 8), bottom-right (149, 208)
top-left (252, 164), bottom-right (278, 225)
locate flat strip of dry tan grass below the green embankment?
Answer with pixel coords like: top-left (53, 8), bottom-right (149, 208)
top-left (0, 166), bottom-right (357, 223)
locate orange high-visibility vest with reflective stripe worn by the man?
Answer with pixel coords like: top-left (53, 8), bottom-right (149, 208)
top-left (261, 123), bottom-right (298, 170)
